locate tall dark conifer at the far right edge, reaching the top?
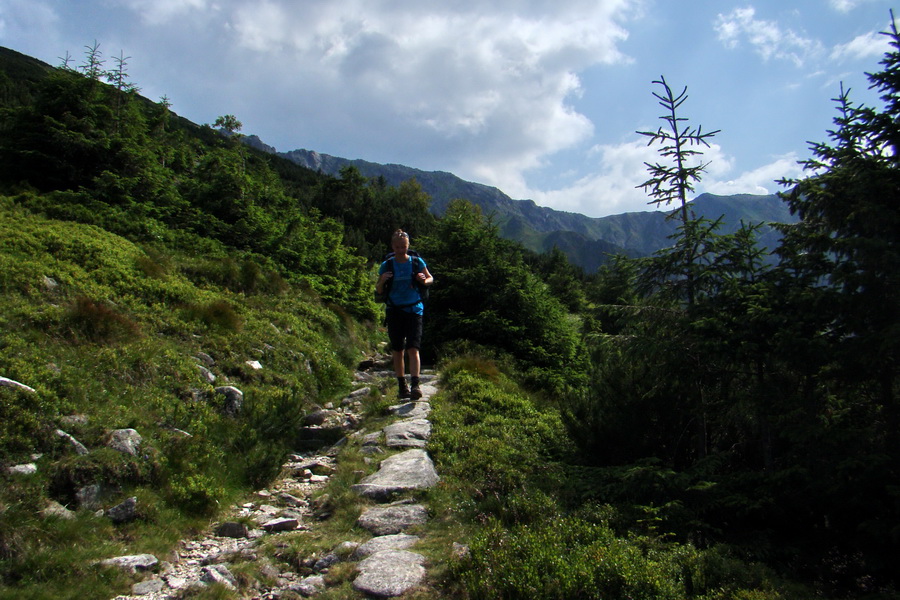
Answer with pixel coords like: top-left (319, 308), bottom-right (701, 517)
top-left (778, 13), bottom-right (900, 434)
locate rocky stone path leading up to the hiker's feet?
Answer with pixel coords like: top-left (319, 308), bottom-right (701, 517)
top-left (108, 364), bottom-right (439, 600)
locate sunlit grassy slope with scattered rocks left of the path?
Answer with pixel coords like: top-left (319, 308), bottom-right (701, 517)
top-left (0, 199), bottom-right (371, 598)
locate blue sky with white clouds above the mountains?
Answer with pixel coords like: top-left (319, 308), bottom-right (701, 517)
top-left (0, 0), bottom-right (900, 217)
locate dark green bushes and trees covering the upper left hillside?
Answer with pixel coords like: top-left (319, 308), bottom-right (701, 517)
top-left (0, 56), bottom-right (376, 317)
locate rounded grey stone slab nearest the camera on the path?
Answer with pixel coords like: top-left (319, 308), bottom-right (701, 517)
top-left (353, 550), bottom-right (425, 598)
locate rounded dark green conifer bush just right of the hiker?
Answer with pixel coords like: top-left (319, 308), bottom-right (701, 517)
top-left (420, 201), bottom-right (587, 390)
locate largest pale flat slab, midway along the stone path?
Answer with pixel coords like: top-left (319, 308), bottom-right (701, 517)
top-left (350, 449), bottom-right (440, 502)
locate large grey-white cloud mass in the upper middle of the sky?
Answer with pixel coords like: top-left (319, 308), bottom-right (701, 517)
top-left (204, 0), bottom-right (644, 190)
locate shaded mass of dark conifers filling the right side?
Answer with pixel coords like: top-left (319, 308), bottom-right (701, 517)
top-left (565, 16), bottom-right (900, 598)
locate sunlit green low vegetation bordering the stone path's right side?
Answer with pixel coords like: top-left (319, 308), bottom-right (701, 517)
top-left (422, 355), bottom-right (812, 600)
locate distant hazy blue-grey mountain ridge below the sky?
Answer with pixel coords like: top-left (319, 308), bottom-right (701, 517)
top-left (272, 146), bottom-right (796, 273)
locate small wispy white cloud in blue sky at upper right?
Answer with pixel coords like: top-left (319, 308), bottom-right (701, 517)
top-left (715, 7), bottom-right (823, 67)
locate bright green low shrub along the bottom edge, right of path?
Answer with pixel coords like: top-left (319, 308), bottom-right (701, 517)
top-left (454, 517), bottom-right (792, 600)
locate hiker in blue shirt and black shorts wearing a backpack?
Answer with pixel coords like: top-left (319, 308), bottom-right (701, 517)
top-left (375, 229), bottom-right (434, 400)
